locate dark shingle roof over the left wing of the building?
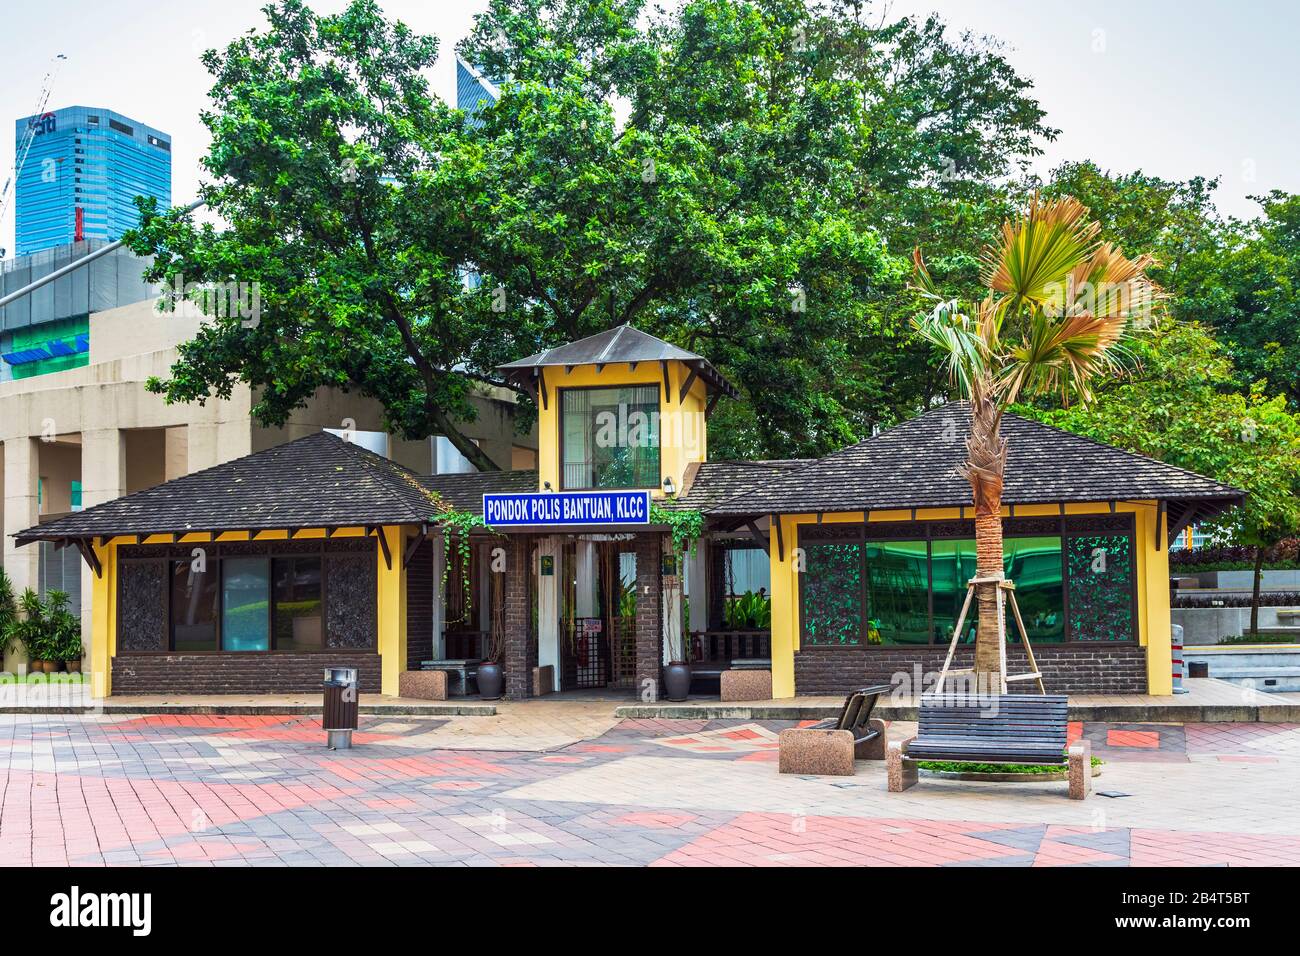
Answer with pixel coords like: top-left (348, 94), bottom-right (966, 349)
top-left (16, 432), bottom-right (445, 541)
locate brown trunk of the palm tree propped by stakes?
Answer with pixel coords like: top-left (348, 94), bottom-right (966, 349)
top-left (962, 382), bottom-right (1006, 693)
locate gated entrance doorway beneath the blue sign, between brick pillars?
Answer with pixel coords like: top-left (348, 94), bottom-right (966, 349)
top-left (559, 535), bottom-right (637, 689)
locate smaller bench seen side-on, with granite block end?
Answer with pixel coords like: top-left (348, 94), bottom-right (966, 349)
top-left (777, 684), bottom-right (893, 777)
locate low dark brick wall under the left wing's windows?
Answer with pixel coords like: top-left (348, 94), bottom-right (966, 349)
top-left (113, 650), bottom-right (380, 696)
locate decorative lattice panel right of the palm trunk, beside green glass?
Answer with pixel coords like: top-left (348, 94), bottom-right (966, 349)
top-left (1066, 535), bottom-right (1135, 641)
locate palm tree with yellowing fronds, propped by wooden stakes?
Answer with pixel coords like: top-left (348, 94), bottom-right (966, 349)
top-left (913, 195), bottom-right (1161, 691)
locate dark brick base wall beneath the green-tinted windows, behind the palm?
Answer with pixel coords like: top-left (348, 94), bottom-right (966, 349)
top-left (794, 644), bottom-right (1147, 695)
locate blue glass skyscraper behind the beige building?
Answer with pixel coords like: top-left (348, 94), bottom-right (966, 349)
top-left (14, 107), bottom-right (172, 256)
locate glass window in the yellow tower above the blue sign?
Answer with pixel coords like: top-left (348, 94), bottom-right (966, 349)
top-left (560, 385), bottom-right (659, 489)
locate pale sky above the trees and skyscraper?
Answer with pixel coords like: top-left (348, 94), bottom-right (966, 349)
top-left (0, 0), bottom-right (1300, 248)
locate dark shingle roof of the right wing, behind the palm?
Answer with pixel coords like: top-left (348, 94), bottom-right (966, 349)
top-left (709, 402), bottom-right (1244, 515)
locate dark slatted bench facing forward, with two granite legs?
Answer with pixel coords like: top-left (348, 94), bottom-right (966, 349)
top-left (885, 693), bottom-right (1092, 800)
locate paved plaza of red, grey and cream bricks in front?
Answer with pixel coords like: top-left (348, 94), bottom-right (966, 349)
top-left (0, 702), bottom-right (1300, 866)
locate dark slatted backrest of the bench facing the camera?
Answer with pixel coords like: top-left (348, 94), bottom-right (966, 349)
top-left (917, 693), bottom-right (1069, 750)
